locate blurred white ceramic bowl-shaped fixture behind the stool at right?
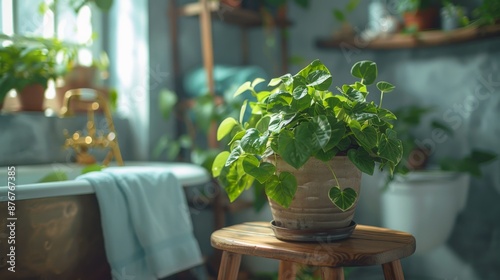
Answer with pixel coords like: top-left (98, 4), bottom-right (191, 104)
top-left (381, 171), bottom-right (470, 253)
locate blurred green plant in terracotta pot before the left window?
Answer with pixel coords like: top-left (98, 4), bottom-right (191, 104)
top-left (0, 35), bottom-right (74, 111)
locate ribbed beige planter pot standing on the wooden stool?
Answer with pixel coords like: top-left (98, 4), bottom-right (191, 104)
top-left (269, 156), bottom-right (361, 231)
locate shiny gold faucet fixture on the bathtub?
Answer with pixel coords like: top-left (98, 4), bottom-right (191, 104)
top-left (60, 88), bottom-right (123, 166)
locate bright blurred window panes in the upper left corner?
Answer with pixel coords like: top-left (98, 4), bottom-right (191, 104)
top-left (0, 0), bottom-right (102, 111)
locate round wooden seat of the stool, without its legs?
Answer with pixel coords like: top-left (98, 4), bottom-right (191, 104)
top-left (211, 222), bottom-right (415, 267)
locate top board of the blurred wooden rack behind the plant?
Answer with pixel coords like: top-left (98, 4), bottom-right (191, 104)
top-left (178, 1), bottom-right (291, 27)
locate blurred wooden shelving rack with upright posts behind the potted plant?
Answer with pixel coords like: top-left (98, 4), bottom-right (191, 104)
top-left (167, 0), bottom-right (291, 235)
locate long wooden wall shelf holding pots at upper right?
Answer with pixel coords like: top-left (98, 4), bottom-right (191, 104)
top-left (316, 24), bottom-right (500, 50)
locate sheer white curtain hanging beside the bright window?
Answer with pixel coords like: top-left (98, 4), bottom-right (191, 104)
top-left (107, 0), bottom-right (150, 160)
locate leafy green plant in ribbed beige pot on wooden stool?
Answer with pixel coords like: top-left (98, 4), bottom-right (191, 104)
top-left (212, 60), bottom-right (403, 240)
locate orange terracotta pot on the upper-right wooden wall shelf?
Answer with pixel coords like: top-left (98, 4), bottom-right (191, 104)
top-left (396, 0), bottom-right (439, 31)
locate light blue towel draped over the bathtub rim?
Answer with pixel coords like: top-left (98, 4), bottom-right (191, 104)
top-left (77, 167), bottom-right (202, 280)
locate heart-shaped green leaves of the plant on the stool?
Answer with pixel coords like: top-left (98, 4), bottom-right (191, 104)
top-left (212, 60), bottom-right (403, 211)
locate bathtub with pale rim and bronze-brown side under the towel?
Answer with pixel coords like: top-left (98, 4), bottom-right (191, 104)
top-left (0, 162), bottom-right (210, 280)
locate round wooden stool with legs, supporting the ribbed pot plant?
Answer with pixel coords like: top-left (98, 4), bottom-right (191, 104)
top-left (211, 222), bottom-right (415, 280)
